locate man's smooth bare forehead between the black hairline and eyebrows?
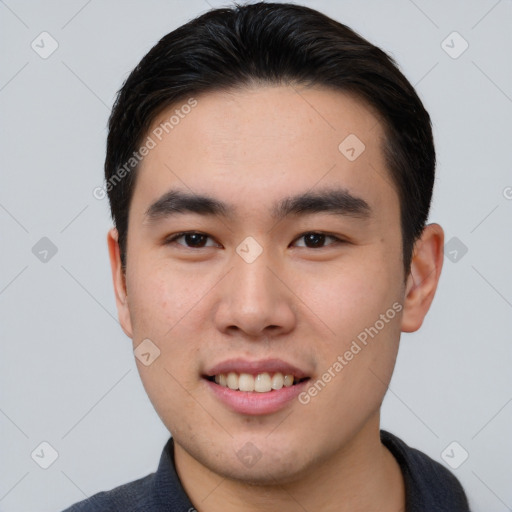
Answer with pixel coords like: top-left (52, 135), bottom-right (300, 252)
top-left (133, 86), bottom-right (397, 220)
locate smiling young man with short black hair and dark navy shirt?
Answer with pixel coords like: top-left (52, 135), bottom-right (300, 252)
top-left (63, 3), bottom-right (469, 512)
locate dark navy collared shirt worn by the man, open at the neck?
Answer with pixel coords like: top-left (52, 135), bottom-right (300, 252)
top-left (64, 430), bottom-right (470, 512)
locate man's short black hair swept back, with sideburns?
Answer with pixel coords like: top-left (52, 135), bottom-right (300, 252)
top-left (105, 2), bottom-right (436, 276)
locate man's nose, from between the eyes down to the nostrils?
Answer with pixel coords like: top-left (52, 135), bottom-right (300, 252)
top-left (215, 251), bottom-right (297, 339)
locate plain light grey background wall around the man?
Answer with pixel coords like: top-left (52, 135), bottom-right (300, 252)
top-left (0, 0), bottom-right (512, 512)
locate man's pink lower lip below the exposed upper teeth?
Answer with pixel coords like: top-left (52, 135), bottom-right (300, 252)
top-left (204, 379), bottom-right (308, 415)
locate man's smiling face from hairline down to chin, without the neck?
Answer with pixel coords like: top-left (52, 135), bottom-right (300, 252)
top-left (111, 86), bottom-right (440, 482)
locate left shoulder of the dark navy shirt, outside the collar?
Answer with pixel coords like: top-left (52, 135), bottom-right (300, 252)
top-left (63, 473), bottom-right (155, 512)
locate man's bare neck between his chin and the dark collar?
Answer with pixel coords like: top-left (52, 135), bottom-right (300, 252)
top-left (174, 415), bottom-right (405, 512)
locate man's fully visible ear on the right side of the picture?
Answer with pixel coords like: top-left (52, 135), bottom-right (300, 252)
top-left (402, 224), bottom-right (444, 332)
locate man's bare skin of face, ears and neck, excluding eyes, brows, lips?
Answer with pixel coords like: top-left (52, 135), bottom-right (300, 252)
top-left (108, 86), bottom-right (444, 512)
